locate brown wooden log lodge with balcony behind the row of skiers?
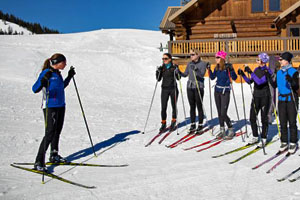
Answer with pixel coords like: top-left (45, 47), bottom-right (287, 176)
top-left (160, 0), bottom-right (300, 66)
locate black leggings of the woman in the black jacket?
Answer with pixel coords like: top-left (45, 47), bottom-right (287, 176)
top-left (161, 88), bottom-right (178, 120)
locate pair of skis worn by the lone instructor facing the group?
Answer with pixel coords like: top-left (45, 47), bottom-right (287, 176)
top-left (10, 162), bottom-right (128, 189)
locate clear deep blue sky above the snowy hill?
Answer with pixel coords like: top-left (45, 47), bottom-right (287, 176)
top-left (0, 0), bottom-right (180, 33)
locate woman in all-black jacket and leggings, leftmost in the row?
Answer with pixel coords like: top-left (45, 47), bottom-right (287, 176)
top-left (156, 53), bottom-right (180, 132)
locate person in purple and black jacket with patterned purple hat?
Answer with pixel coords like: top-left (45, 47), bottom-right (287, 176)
top-left (238, 53), bottom-right (273, 146)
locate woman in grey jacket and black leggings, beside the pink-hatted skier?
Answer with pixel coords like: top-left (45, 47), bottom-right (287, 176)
top-left (181, 49), bottom-right (208, 132)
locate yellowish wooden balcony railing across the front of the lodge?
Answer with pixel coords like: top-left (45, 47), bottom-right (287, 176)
top-left (168, 37), bottom-right (300, 58)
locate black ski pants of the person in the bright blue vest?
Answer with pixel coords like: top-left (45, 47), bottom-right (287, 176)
top-left (278, 98), bottom-right (298, 143)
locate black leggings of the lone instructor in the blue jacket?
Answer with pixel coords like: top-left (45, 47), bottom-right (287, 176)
top-left (36, 107), bottom-right (65, 163)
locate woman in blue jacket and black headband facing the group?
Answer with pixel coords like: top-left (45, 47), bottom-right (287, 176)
top-left (32, 53), bottom-right (76, 171)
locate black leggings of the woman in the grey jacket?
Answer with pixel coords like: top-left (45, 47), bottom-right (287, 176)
top-left (187, 88), bottom-right (204, 124)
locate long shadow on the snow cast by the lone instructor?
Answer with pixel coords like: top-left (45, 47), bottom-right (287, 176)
top-left (48, 130), bottom-right (140, 172)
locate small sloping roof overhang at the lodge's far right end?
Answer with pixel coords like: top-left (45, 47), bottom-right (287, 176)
top-left (273, 1), bottom-right (300, 28)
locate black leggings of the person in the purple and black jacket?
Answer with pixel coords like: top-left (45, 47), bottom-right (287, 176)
top-left (250, 96), bottom-right (270, 139)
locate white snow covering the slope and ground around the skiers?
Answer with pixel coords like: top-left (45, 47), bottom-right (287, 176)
top-left (0, 29), bottom-right (300, 200)
